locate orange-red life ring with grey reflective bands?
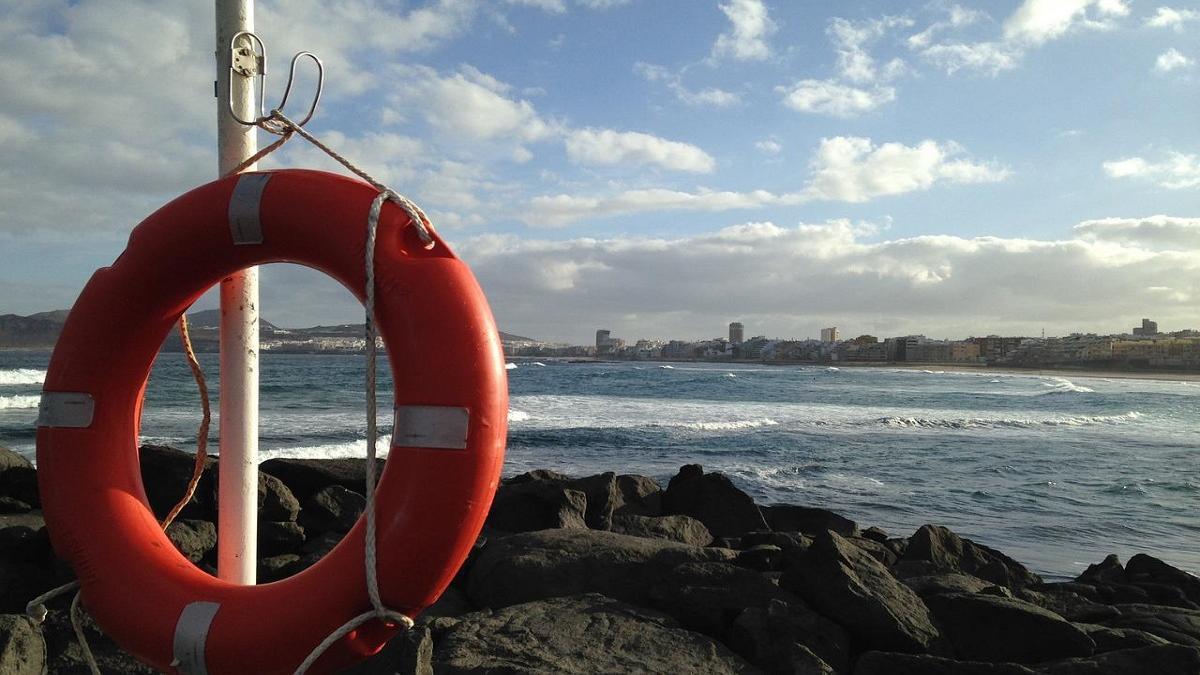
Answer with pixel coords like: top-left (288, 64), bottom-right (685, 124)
top-left (37, 169), bottom-right (508, 674)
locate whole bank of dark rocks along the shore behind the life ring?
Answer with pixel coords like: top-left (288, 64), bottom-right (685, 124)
top-left (0, 447), bottom-right (1200, 675)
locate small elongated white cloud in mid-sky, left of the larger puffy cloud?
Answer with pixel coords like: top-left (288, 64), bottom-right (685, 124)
top-left (566, 129), bottom-right (716, 173)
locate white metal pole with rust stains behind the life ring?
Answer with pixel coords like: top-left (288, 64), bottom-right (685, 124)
top-left (216, 0), bottom-right (258, 584)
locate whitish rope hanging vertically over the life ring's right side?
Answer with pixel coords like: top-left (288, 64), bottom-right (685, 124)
top-left (296, 190), bottom-right (424, 675)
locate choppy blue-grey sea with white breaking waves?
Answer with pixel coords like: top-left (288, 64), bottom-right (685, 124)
top-left (0, 352), bottom-right (1200, 578)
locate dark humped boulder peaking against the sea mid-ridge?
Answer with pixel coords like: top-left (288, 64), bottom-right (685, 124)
top-left (662, 465), bottom-right (767, 537)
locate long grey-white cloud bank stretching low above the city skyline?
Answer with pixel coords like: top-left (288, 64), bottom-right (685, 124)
top-left (457, 220), bottom-right (1200, 342)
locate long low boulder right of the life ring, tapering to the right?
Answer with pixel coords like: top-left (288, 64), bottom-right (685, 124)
top-left (467, 530), bottom-right (734, 608)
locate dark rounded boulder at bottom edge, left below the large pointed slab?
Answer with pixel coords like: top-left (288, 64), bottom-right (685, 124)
top-left (726, 599), bottom-right (850, 673)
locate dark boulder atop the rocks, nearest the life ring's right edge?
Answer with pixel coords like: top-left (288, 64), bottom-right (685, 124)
top-left (487, 480), bottom-right (588, 532)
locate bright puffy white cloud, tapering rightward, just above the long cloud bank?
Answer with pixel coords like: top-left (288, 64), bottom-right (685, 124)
top-left (805, 136), bottom-right (1009, 202)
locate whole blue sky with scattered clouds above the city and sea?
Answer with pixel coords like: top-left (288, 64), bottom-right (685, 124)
top-left (0, 0), bottom-right (1200, 342)
